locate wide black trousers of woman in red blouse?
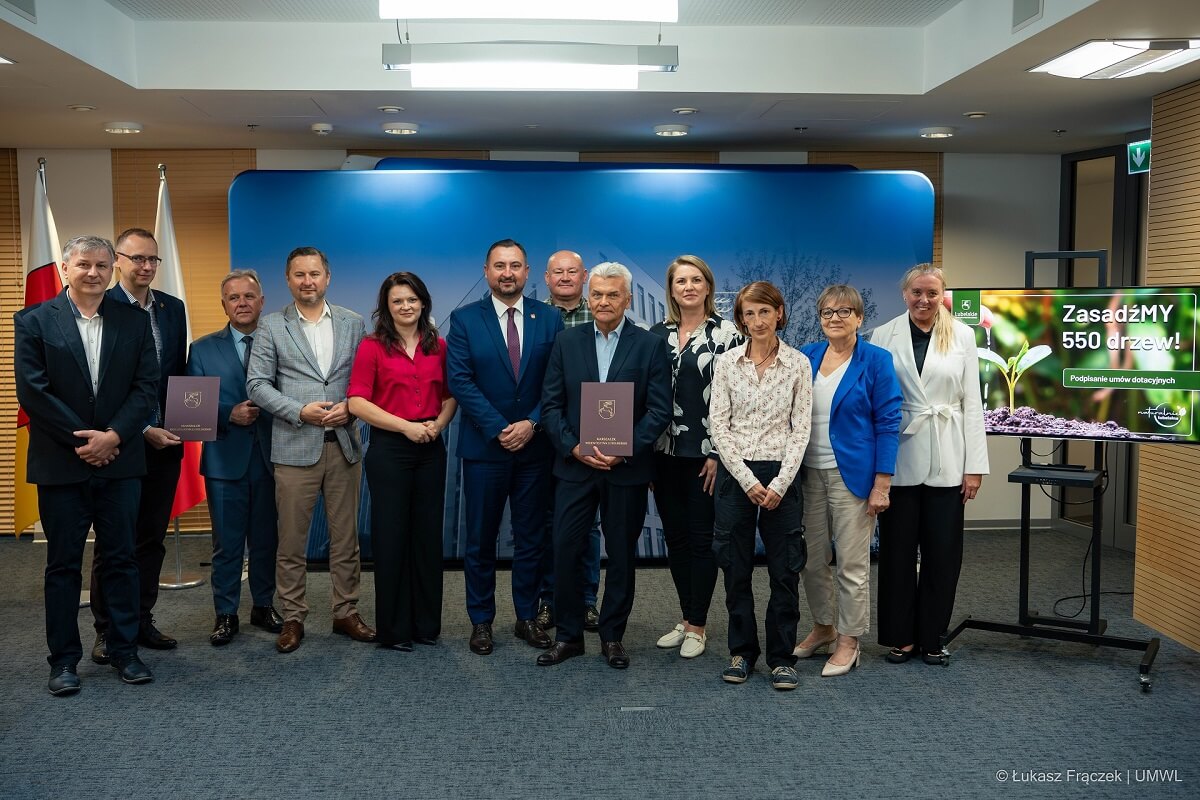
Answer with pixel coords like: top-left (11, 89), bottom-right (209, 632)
top-left (364, 427), bottom-right (446, 644)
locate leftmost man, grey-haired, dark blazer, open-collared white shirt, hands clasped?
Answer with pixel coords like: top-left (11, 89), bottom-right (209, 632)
top-left (13, 236), bottom-right (158, 696)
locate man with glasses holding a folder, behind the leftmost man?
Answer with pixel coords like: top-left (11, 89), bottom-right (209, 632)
top-left (91, 228), bottom-right (187, 664)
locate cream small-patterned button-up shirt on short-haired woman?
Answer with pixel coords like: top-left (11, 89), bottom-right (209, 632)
top-left (708, 342), bottom-right (812, 497)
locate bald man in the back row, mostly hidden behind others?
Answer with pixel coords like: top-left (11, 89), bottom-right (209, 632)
top-left (538, 249), bottom-right (600, 631)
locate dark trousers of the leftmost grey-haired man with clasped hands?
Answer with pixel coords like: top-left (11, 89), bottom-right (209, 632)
top-left (37, 477), bottom-right (142, 667)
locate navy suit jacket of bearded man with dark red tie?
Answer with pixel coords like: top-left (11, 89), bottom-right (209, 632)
top-left (446, 295), bottom-right (563, 461)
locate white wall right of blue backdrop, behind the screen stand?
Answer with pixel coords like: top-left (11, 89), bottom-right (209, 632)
top-left (942, 154), bottom-right (1061, 527)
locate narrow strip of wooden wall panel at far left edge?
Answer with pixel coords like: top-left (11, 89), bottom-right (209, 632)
top-left (0, 149), bottom-right (20, 535)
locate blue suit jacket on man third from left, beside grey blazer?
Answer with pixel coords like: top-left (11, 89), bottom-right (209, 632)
top-left (187, 325), bottom-right (271, 481)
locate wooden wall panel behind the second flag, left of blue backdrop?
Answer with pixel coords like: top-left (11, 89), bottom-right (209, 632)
top-left (113, 150), bottom-right (255, 530)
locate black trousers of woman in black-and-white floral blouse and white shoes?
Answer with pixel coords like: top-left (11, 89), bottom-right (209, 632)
top-left (654, 453), bottom-right (716, 627)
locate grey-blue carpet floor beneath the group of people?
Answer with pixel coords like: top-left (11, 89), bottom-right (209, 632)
top-left (0, 533), bottom-right (1200, 800)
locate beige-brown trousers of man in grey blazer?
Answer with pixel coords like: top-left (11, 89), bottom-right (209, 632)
top-left (275, 441), bottom-right (362, 622)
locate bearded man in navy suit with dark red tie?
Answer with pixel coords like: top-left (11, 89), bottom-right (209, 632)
top-left (446, 239), bottom-right (563, 656)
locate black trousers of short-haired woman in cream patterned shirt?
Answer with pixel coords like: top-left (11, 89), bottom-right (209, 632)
top-left (713, 461), bottom-right (808, 669)
